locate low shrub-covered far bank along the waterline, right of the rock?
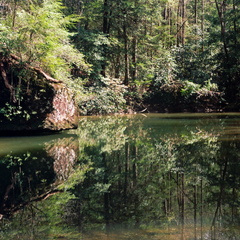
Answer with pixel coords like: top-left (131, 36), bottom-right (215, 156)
top-left (78, 80), bottom-right (232, 115)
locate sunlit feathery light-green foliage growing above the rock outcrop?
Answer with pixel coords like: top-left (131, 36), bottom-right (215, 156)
top-left (0, 0), bottom-right (87, 80)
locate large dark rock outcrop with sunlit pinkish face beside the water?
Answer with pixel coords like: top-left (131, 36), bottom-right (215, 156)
top-left (0, 55), bottom-right (78, 134)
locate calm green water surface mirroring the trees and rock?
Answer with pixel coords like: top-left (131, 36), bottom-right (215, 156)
top-left (0, 113), bottom-right (240, 240)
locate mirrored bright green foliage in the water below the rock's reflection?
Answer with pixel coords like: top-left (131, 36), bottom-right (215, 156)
top-left (0, 156), bottom-right (90, 239)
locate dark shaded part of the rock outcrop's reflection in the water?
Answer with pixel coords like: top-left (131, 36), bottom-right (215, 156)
top-left (0, 151), bottom-right (53, 212)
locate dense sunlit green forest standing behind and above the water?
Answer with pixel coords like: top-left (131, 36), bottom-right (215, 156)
top-left (0, 0), bottom-right (240, 115)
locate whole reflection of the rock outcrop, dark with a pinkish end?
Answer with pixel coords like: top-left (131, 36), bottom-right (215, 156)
top-left (0, 137), bottom-right (78, 214)
